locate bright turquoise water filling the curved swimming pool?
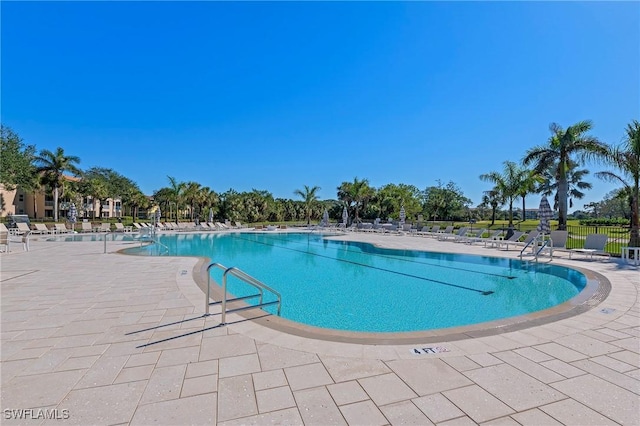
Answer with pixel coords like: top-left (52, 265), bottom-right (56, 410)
top-left (128, 233), bottom-right (586, 332)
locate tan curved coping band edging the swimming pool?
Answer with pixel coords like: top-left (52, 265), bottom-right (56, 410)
top-left (184, 231), bottom-right (611, 345)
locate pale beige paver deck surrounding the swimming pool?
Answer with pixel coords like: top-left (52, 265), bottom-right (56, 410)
top-left (0, 233), bottom-right (640, 425)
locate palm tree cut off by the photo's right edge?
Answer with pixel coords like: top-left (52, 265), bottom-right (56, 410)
top-left (595, 120), bottom-right (640, 247)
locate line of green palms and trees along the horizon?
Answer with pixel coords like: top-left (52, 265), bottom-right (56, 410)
top-left (0, 120), bottom-right (640, 246)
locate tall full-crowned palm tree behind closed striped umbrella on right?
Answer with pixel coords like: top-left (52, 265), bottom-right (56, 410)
top-left (522, 120), bottom-right (608, 231)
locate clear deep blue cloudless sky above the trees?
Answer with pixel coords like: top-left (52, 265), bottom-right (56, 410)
top-left (1, 1), bottom-right (640, 208)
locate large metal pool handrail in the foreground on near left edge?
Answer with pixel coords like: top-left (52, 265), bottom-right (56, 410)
top-left (205, 262), bottom-right (282, 325)
